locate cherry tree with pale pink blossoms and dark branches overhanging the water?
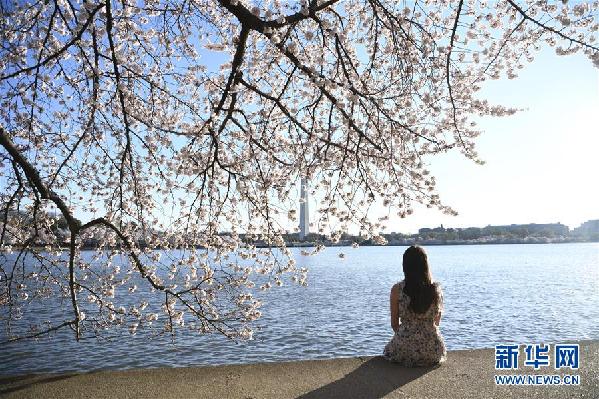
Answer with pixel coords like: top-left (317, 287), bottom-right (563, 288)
top-left (0, 0), bottom-right (599, 342)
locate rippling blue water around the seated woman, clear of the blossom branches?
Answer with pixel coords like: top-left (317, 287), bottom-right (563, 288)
top-left (0, 243), bottom-right (599, 374)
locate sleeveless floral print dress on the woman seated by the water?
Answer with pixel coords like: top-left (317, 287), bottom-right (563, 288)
top-left (383, 281), bottom-right (447, 367)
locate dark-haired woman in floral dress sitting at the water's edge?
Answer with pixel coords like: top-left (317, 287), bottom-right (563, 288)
top-left (383, 246), bottom-right (447, 367)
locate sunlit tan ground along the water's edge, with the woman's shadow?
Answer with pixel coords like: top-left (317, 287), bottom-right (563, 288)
top-left (0, 341), bottom-right (599, 399)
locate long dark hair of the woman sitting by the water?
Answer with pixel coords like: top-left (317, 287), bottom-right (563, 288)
top-left (403, 245), bottom-right (438, 313)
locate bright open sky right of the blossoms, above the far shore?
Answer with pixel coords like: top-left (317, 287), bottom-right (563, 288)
top-left (381, 49), bottom-right (599, 233)
